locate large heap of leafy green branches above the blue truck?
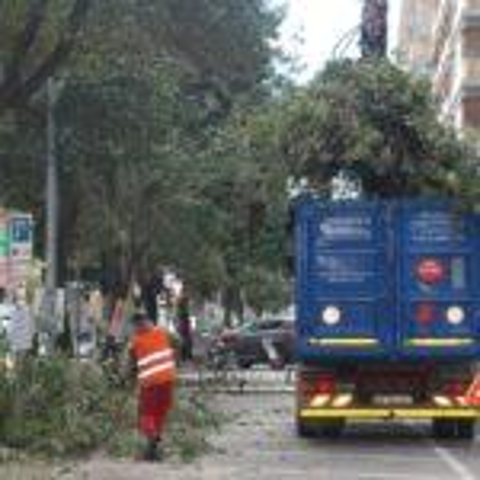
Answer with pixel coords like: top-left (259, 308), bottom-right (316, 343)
top-left (280, 59), bottom-right (467, 196)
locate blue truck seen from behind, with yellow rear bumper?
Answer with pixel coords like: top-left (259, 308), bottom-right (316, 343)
top-left (294, 196), bottom-right (480, 439)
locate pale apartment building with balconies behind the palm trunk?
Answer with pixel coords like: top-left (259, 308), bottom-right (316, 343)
top-left (399, 0), bottom-right (480, 130)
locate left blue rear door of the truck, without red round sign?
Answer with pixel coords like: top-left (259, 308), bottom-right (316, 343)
top-left (296, 201), bottom-right (395, 356)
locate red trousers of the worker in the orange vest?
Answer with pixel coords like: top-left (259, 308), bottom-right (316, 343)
top-left (138, 382), bottom-right (173, 440)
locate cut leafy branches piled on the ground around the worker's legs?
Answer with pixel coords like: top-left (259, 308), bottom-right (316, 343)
top-left (0, 357), bottom-right (220, 458)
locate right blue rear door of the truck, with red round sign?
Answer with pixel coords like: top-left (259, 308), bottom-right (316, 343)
top-left (397, 201), bottom-right (479, 358)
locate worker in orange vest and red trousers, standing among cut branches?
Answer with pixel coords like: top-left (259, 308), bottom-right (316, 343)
top-left (130, 313), bottom-right (176, 460)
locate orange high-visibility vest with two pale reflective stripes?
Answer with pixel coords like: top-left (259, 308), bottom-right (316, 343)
top-left (131, 327), bottom-right (176, 387)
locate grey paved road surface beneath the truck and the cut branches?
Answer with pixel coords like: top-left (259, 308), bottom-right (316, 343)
top-left (0, 376), bottom-right (480, 480)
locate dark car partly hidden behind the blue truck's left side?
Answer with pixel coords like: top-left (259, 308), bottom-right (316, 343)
top-left (211, 319), bottom-right (295, 368)
